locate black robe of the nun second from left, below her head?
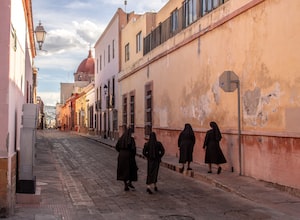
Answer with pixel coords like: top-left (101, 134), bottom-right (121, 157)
top-left (143, 141), bottom-right (165, 185)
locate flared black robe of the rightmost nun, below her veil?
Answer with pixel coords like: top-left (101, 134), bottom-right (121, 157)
top-left (203, 129), bottom-right (227, 164)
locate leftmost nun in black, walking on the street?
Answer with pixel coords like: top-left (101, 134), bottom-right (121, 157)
top-left (116, 128), bottom-right (138, 191)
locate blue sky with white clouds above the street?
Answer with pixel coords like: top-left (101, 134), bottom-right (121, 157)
top-left (32, 0), bottom-right (168, 106)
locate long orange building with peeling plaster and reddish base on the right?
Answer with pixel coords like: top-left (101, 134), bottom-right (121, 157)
top-left (118, 0), bottom-right (300, 190)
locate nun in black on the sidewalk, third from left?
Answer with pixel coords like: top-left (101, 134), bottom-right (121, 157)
top-left (178, 124), bottom-right (196, 173)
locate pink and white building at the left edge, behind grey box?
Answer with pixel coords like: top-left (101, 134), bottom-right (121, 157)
top-left (0, 0), bottom-right (37, 218)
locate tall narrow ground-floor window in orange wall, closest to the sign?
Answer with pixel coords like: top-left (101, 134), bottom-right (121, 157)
top-left (145, 83), bottom-right (152, 136)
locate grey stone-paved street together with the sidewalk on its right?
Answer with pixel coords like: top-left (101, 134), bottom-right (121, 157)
top-left (9, 132), bottom-right (300, 220)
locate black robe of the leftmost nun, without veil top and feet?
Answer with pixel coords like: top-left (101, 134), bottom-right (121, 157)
top-left (116, 138), bottom-right (138, 181)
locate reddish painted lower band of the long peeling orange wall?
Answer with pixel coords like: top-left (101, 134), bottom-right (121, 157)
top-left (134, 128), bottom-right (300, 191)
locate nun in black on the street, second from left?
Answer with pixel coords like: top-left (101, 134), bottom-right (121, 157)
top-left (143, 132), bottom-right (165, 194)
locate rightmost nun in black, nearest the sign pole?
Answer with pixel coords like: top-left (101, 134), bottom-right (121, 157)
top-left (203, 121), bottom-right (227, 174)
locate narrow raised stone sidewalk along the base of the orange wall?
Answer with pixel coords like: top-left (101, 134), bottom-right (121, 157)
top-left (76, 133), bottom-right (300, 217)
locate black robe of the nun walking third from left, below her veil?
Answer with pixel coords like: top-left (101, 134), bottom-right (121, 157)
top-left (178, 131), bottom-right (196, 163)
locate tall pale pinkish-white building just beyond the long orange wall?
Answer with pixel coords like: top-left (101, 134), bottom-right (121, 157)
top-left (95, 8), bottom-right (138, 139)
